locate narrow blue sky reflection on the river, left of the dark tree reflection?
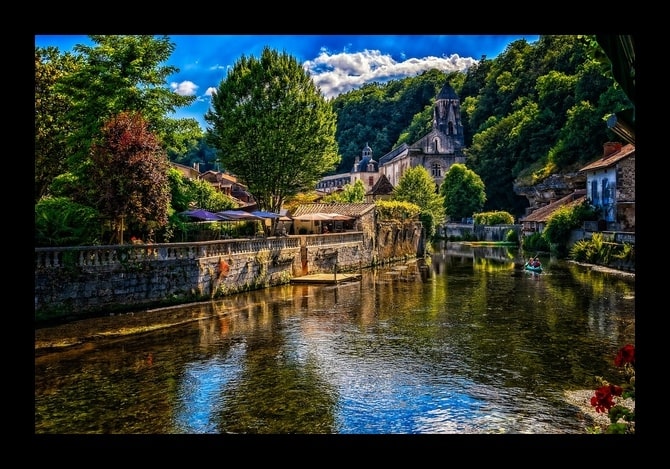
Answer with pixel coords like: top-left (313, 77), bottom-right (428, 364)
top-left (175, 344), bottom-right (244, 434)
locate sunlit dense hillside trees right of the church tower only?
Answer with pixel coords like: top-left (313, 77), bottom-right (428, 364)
top-left (463, 35), bottom-right (628, 215)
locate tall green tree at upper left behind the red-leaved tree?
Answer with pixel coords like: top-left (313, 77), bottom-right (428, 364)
top-left (56, 35), bottom-right (202, 171)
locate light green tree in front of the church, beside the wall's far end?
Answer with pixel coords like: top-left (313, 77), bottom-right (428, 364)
top-left (392, 166), bottom-right (446, 238)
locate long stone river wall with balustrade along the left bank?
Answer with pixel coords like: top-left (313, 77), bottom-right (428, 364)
top-left (35, 224), bottom-right (421, 318)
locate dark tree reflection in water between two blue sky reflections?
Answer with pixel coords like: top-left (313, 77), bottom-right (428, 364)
top-left (218, 303), bottom-right (337, 434)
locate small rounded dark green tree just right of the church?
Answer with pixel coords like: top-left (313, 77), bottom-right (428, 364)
top-left (440, 163), bottom-right (486, 220)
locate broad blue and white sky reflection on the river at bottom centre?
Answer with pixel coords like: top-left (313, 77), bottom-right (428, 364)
top-left (285, 321), bottom-right (498, 434)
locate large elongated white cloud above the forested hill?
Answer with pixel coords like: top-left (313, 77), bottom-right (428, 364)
top-left (303, 50), bottom-right (478, 98)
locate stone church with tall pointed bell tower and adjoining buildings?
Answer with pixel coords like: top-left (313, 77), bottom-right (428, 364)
top-left (317, 83), bottom-right (465, 195)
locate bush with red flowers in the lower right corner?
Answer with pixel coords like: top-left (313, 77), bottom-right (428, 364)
top-left (591, 344), bottom-right (635, 433)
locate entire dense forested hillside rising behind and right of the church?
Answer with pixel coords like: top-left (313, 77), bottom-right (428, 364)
top-left (333, 35), bottom-right (631, 214)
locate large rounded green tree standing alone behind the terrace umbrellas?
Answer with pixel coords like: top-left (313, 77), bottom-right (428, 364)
top-left (205, 46), bottom-right (340, 212)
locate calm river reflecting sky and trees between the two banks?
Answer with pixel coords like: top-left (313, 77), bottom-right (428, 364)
top-left (35, 243), bottom-right (635, 434)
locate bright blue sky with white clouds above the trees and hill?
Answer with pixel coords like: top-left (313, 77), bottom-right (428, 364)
top-left (35, 34), bottom-right (539, 129)
